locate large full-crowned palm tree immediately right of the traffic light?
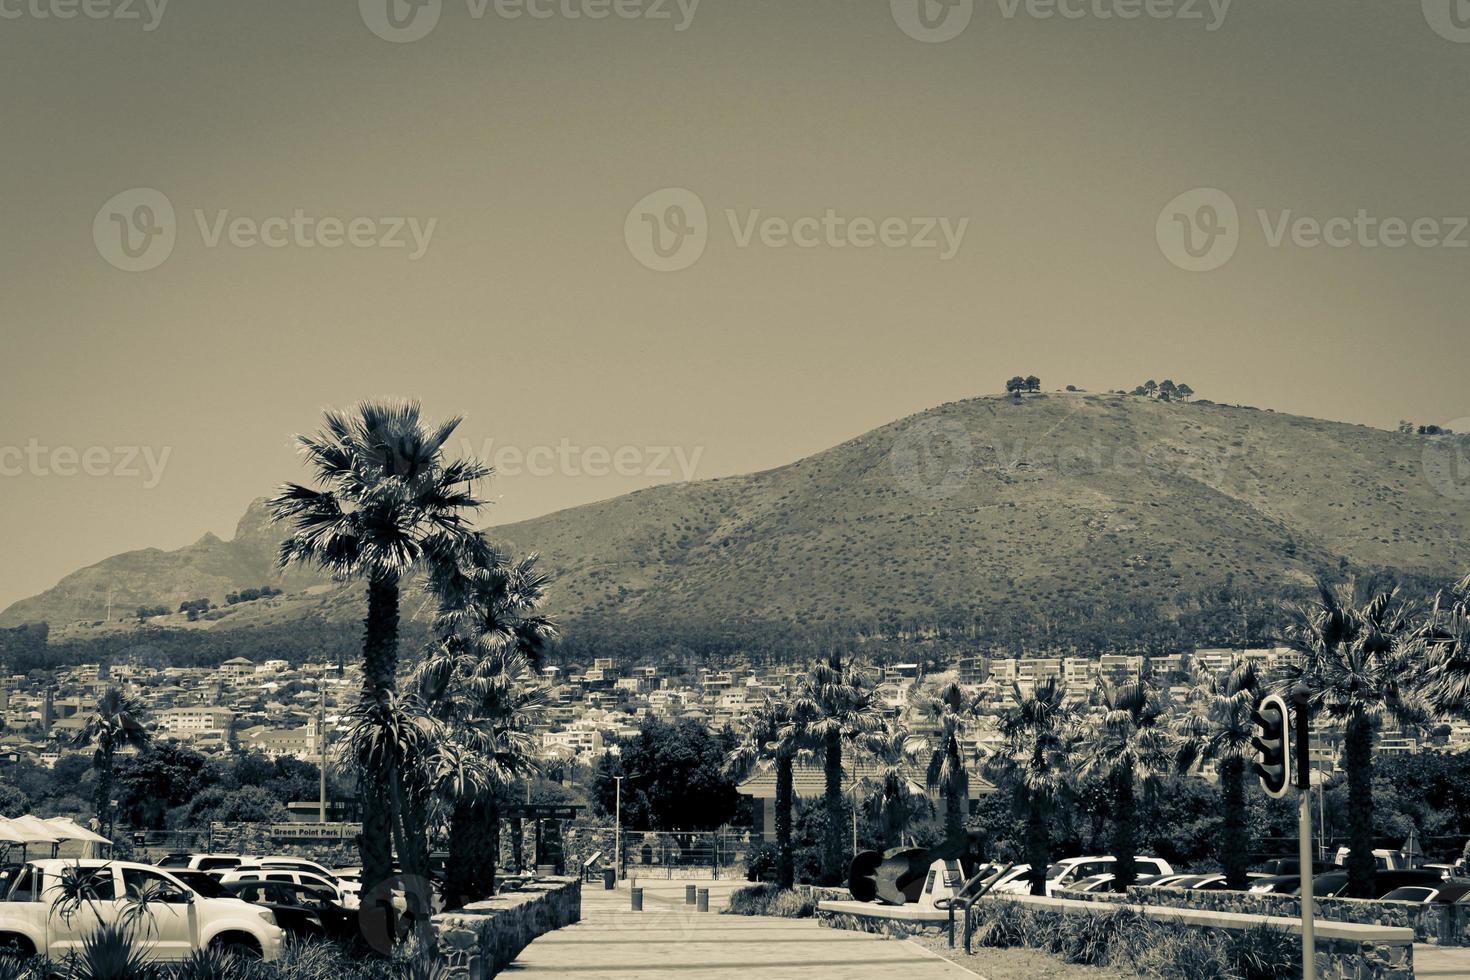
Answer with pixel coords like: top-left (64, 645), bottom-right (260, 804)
top-left (1277, 582), bottom-right (1429, 898)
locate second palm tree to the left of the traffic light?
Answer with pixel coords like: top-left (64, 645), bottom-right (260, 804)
top-left (1078, 674), bottom-right (1175, 892)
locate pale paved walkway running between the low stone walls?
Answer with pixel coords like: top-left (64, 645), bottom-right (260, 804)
top-left (506, 879), bottom-right (976, 980)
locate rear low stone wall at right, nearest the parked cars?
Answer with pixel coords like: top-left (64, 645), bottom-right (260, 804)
top-left (1057, 886), bottom-right (1470, 946)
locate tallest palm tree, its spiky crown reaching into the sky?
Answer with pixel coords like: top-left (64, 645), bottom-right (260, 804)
top-left (270, 403), bottom-right (490, 889)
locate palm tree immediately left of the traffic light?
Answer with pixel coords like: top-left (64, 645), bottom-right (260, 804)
top-left (1177, 661), bottom-right (1266, 890)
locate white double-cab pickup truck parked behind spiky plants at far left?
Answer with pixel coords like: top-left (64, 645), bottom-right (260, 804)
top-left (0, 858), bottom-right (282, 961)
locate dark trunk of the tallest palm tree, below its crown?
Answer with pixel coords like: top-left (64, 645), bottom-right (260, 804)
top-left (357, 576), bottom-right (399, 895)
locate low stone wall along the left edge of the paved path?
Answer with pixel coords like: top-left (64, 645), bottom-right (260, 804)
top-left (434, 877), bottom-right (582, 980)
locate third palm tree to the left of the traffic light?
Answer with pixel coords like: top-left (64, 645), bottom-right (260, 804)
top-left (991, 677), bottom-right (1075, 895)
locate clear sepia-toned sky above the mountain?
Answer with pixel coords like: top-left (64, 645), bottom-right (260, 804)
top-left (0, 0), bottom-right (1470, 607)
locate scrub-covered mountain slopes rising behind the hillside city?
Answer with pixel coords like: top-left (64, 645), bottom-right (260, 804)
top-left (0, 392), bottom-right (1470, 652)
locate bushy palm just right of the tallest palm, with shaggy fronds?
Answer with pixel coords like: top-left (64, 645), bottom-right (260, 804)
top-left (415, 535), bottom-right (557, 901)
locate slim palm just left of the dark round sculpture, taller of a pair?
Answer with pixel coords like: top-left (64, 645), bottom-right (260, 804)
top-left (797, 654), bottom-right (882, 884)
